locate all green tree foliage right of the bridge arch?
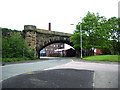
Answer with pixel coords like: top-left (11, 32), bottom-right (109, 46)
top-left (71, 12), bottom-right (120, 54)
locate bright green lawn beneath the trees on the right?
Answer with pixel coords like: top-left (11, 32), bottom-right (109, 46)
top-left (83, 55), bottom-right (120, 62)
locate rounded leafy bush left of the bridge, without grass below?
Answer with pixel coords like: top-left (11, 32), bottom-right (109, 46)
top-left (2, 33), bottom-right (34, 61)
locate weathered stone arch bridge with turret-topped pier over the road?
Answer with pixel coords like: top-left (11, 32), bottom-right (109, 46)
top-left (23, 25), bottom-right (73, 57)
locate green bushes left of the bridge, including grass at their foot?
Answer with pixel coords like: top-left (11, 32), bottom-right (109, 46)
top-left (1, 29), bottom-right (36, 62)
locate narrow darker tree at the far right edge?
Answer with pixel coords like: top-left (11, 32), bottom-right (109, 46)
top-left (107, 17), bottom-right (120, 54)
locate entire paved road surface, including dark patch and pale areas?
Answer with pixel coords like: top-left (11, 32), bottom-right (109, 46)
top-left (2, 58), bottom-right (120, 88)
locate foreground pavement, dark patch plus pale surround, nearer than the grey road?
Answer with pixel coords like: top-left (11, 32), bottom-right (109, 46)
top-left (2, 57), bottom-right (120, 89)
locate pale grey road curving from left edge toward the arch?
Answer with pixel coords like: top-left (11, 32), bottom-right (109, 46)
top-left (0, 57), bottom-right (71, 81)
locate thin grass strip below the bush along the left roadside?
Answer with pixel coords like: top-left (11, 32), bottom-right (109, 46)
top-left (2, 57), bottom-right (37, 62)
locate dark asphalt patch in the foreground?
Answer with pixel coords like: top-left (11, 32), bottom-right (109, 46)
top-left (2, 69), bottom-right (94, 88)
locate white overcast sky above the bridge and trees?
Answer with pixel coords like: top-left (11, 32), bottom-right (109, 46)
top-left (0, 0), bottom-right (119, 33)
